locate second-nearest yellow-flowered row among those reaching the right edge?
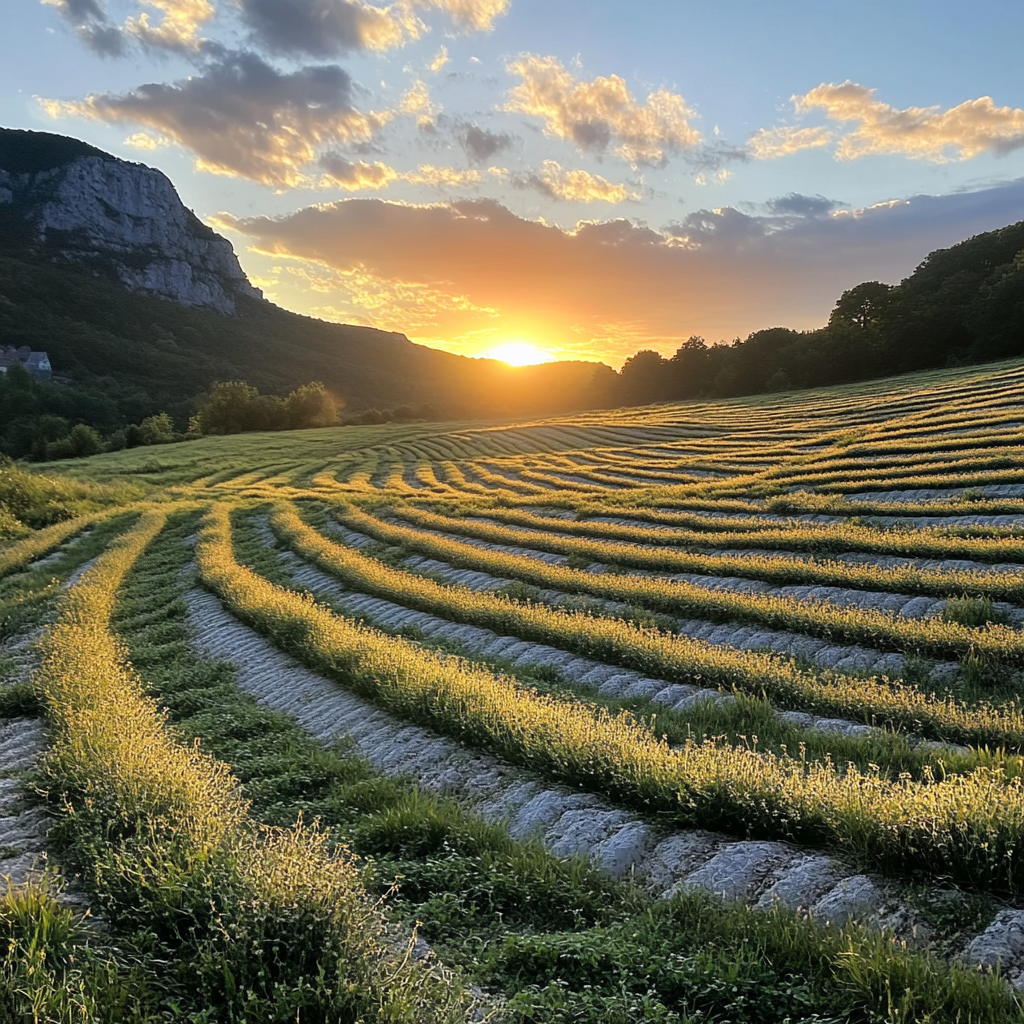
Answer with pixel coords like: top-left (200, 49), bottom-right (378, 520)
top-left (270, 506), bottom-right (1024, 749)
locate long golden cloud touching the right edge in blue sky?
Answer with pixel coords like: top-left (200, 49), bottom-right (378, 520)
top-left (750, 81), bottom-right (1024, 164)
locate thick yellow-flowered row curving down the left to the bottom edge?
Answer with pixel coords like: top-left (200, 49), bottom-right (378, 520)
top-left (36, 511), bottom-right (460, 1024)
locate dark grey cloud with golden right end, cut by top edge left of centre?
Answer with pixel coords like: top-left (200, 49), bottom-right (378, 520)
top-left (239, 0), bottom-right (411, 57)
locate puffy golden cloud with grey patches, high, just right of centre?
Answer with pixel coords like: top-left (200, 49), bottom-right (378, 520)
top-left (504, 53), bottom-right (700, 166)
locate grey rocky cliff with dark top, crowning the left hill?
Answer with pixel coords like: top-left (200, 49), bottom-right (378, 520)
top-left (0, 129), bottom-right (262, 313)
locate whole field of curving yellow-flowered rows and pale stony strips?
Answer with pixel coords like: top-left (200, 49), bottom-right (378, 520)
top-left (6, 361), bottom-right (1024, 1024)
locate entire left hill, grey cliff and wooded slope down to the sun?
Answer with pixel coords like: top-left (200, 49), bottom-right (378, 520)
top-left (0, 122), bottom-right (610, 430)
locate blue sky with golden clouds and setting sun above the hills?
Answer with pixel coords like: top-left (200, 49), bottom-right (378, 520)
top-left (6, 0), bottom-right (1024, 368)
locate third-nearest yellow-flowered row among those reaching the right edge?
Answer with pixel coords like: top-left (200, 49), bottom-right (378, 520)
top-left (346, 507), bottom-right (1024, 665)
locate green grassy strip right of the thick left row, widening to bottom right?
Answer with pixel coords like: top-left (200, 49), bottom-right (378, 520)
top-left (116, 507), bottom-right (1018, 1024)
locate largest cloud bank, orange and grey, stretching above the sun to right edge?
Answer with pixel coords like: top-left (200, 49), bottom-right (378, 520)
top-left (221, 180), bottom-right (1024, 358)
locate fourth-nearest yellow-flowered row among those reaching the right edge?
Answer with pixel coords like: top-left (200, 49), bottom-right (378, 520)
top-left (400, 508), bottom-right (1024, 601)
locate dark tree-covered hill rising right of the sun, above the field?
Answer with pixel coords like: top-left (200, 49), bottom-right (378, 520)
top-left (595, 221), bottom-right (1024, 406)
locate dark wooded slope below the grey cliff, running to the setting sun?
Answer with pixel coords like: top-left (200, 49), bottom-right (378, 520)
top-left (0, 254), bottom-right (611, 433)
